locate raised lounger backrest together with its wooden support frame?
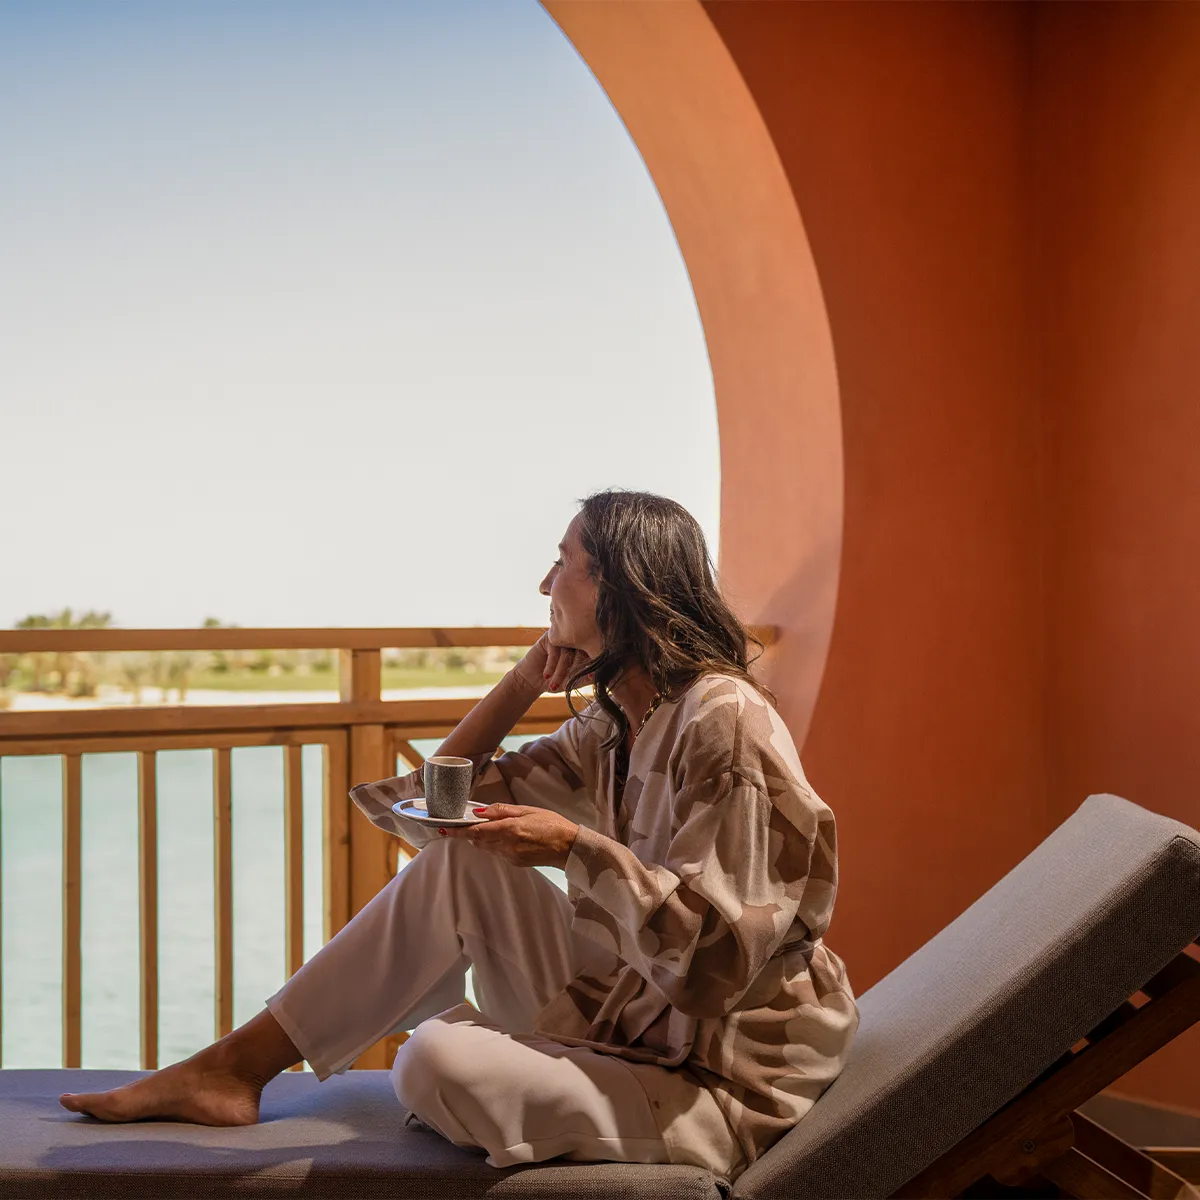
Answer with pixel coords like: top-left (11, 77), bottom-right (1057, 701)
top-left (738, 796), bottom-right (1200, 1200)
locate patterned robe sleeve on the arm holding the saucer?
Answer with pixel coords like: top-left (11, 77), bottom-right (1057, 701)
top-left (566, 770), bottom-right (816, 1018)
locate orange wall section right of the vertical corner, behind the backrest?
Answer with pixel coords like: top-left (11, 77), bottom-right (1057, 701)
top-left (1032, 4), bottom-right (1200, 1110)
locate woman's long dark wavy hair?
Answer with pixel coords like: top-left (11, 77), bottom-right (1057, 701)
top-left (566, 488), bottom-right (775, 750)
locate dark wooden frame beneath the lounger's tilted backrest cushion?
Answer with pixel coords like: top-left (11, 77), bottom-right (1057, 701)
top-left (895, 938), bottom-right (1200, 1200)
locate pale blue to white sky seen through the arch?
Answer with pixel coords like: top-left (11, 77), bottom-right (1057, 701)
top-left (0, 0), bottom-right (720, 626)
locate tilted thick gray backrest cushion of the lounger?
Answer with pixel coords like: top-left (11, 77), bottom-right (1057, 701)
top-left (733, 796), bottom-right (1200, 1200)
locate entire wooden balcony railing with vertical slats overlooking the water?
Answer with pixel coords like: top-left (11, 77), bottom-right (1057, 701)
top-left (0, 626), bottom-right (773, 1069)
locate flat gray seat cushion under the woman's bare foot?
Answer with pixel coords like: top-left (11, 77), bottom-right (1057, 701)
top-left (0, 1070), bottom-right (728, 1200)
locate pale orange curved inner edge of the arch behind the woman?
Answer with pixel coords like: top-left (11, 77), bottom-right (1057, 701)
top-left (542, 0), bottom-right (842, 745)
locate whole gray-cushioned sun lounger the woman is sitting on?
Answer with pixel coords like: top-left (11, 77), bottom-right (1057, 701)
top-left (0, 796), bottom-right (1200, 1200)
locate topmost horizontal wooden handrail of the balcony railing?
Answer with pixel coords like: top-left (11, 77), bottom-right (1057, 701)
top-left (0, 625), bottom-right (775, 654)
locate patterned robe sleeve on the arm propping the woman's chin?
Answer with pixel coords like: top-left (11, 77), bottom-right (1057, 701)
top-left (350, 706), bottom-right (596, 850)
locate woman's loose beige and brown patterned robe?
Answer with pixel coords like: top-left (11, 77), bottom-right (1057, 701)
top-left (350, 674), bottom-right (858, 1162)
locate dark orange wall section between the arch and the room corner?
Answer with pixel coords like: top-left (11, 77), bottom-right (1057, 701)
top-left (707, 2), bottom-right (1055, 1008)
